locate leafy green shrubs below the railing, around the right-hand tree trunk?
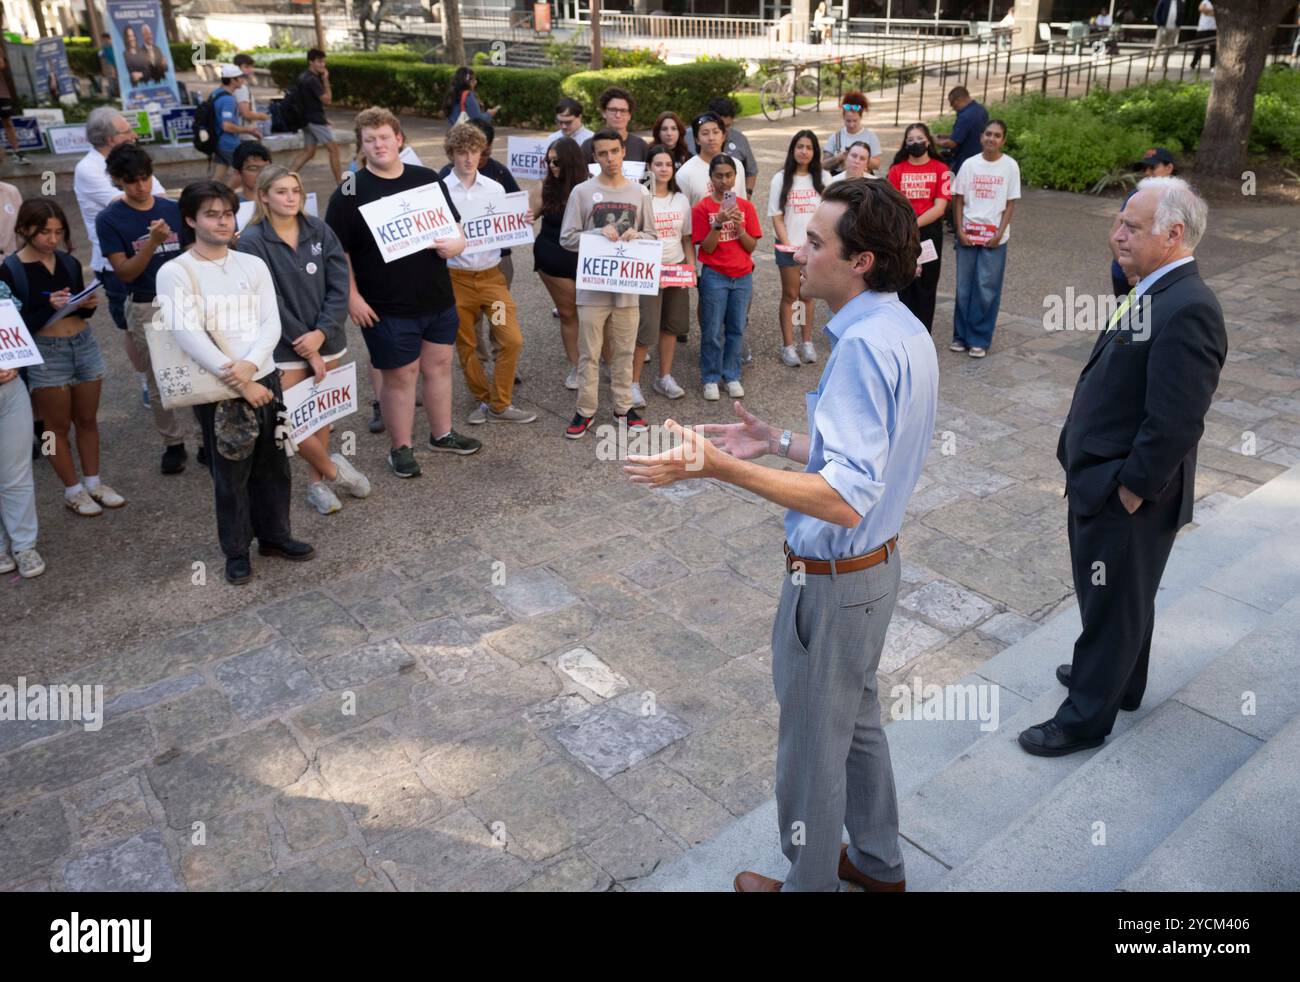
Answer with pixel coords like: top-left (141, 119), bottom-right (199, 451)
top-left (931, 66), bottom-right (1300, 191)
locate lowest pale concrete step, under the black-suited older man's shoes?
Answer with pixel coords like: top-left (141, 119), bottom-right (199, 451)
top-left (636, 467), bottom-right (1300, 890)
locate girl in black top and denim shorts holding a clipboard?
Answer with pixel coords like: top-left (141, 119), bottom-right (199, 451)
top-left (0, 198), bottom-right (126, 516)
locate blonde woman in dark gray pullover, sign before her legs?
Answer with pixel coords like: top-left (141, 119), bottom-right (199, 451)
top-left (239, 164), bottom-right (371, 515)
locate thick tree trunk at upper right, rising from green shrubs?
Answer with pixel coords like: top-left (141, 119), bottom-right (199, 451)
top-left (1196, 0), bottom-right (1294, 178)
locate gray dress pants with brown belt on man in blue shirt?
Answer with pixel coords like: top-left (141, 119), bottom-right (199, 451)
top-left (772, 550), bottom-right (904, 891)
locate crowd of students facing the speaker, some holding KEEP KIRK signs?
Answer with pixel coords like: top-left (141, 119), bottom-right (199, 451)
top-left (0, 76), bottom-right (1019, 583)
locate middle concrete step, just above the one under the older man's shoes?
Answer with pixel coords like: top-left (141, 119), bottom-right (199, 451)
top-left (941, 595), bottom-right (1300, 890)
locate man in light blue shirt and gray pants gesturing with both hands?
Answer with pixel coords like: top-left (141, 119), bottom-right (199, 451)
top-left (625, 179), bottom-right (939, 892)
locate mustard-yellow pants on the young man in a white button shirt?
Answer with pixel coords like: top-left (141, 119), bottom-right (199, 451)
top-left (449, 267), bottom-right (524, 412)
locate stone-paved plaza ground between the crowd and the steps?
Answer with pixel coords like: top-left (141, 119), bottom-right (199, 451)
top-left (0, 105), bottom-right (1300, 890)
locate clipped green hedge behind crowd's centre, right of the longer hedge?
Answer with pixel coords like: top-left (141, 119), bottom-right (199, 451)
top-left (560, 61), bottom-right (745, 130)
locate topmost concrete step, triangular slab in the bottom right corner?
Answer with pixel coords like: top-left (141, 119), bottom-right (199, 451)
top-left (1119, 717), bottom-right (1300, 892)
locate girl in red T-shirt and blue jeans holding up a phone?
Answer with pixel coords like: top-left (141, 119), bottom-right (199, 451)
top-left (690, 153), bottom-right (763, 402)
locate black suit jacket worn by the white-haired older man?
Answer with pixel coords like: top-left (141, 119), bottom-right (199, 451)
top-left (1057, 260), bottom-right (1227, 527)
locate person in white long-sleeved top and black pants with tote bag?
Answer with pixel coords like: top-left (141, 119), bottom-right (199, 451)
top-left (156, 181), bottom-right (316, 584)
